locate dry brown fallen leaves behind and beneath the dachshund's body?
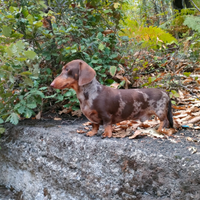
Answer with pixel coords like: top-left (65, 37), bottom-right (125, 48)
top-left (61, 51), bottom-right (200, 145)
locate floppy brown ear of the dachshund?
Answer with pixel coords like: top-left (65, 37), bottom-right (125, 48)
top-left (78, 62), bottom-right (96, 86)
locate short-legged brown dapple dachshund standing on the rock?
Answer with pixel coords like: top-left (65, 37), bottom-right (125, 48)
top-left (51, 60), bottom-right (173, 137)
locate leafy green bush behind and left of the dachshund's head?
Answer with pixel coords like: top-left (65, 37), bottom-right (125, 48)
top-left (0, 0), bottom-right (123, 127)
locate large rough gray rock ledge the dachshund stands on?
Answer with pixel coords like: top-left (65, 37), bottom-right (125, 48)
top-left (0, 120), bottom-right (200, 200)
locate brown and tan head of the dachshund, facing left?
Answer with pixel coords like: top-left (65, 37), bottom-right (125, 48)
top-left (51, 60), bottom-right (96, 91)
